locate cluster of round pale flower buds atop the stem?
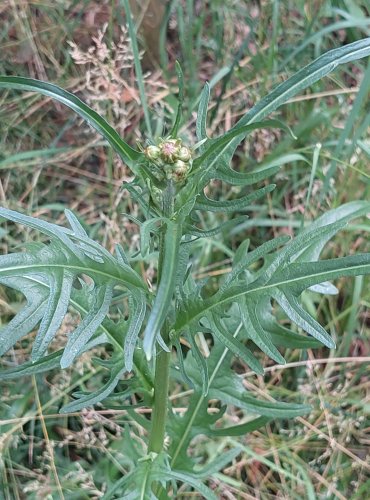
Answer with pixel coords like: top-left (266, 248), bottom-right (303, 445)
top-left (144, 139), bottom-right (192, 183)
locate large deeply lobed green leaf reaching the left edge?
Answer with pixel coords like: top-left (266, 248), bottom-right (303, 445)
top-left (0, 208), bottom-right (151, 394)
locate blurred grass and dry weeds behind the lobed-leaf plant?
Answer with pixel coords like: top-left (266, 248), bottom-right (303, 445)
top-left (0, 0), bottom-right (370, 500)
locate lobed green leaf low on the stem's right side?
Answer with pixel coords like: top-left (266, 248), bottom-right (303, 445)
top-left (168, 336), bottom-right (310, 477)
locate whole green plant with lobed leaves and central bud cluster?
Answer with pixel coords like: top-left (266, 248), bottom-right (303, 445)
top-left (0, 34), bottom-right (370, 499)
